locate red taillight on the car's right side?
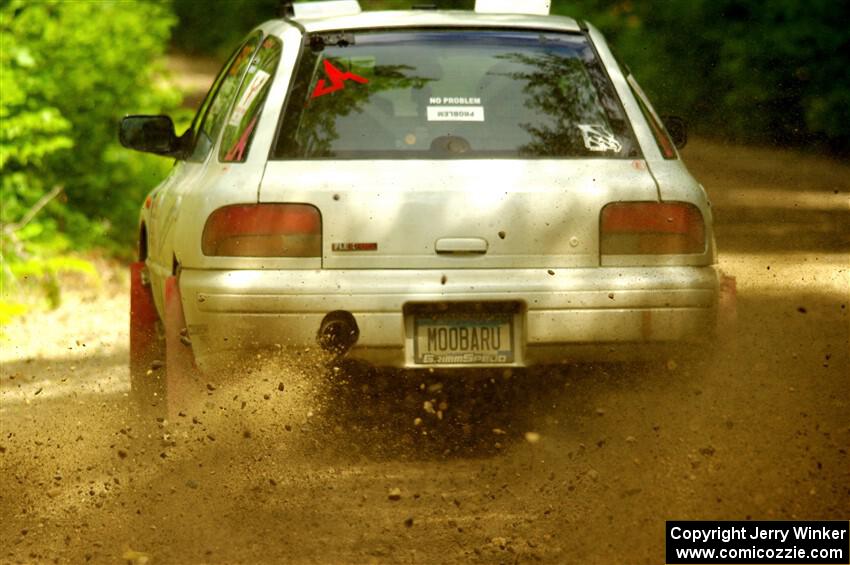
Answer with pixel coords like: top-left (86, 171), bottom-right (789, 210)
top-left (599, 202), bottom-right (705, 255)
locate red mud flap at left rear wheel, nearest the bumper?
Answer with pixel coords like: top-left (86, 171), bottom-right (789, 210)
top-left (165, 276), bottom-right (199, 419)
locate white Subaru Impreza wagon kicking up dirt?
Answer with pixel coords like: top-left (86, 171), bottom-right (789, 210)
top-left (120, 0), bottom-right (723, 414)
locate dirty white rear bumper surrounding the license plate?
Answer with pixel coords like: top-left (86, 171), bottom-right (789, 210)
top-left (180, 267), bottom-right (719, 369)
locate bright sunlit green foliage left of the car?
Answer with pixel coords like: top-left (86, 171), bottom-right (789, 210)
top-left (0, 0), bottom-right (180, 318)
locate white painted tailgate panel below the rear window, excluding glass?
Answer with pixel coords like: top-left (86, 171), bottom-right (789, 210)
top-left (260, 159), bottom-right (657, 269)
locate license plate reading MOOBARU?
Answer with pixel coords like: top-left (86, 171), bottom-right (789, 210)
top-left (413, 313), bottom-right (514, 365)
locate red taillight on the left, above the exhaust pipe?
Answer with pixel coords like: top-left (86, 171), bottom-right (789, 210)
top-left (202, 204), bottom-right (322, 257)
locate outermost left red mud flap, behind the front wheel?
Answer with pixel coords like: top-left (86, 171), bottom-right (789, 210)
top-left (130, 261), bottom-right (158, 375)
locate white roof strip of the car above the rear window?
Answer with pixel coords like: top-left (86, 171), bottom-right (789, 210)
top-left (288, 10), bottom-right (580, 32)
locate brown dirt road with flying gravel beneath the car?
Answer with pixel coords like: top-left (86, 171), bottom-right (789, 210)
top-left (0, 142), bottom-right (850, 563)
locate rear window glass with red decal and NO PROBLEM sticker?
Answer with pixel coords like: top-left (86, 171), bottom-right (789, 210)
top-left (273, 31), bottom-right (637, 159)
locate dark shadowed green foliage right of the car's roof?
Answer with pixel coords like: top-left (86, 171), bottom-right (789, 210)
top-left (554, 0), bottom-right (850, 151)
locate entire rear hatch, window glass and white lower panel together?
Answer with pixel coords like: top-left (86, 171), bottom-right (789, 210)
top-left (259, 29), bottom-right (657, 269)
